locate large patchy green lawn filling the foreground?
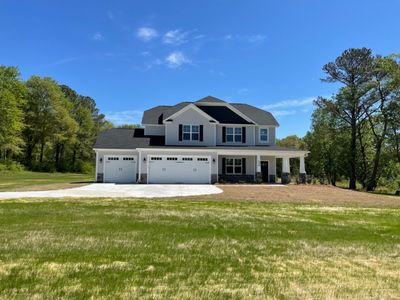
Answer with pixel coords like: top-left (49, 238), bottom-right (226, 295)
top-left (0, 199), bottom-right (400, 299)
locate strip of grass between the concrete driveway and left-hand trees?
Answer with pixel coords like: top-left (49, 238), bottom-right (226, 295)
top-left (0, 171), bottom-right (93, 192)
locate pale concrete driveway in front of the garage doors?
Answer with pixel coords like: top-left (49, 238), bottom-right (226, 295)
top-left (0, 183), bottom-right (223, 199)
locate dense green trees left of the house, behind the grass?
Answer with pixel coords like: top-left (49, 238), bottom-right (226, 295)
top-left (0, 66), bottom-right (112, 172)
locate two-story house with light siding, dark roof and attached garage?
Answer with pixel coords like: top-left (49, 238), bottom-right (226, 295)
top-left (94, 96), bottom-right (307, 183)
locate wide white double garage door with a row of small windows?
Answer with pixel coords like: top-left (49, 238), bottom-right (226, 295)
top-left (147, 155), bottom-right (211, 183)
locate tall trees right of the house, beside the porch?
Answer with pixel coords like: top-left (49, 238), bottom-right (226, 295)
top-left (280, 48), bottom-right (400, 191)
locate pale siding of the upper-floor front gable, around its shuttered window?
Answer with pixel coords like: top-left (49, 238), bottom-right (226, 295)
top-left (165, 108), bottom-right (215, 146)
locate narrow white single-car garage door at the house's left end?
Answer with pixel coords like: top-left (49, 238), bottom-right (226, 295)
top-left (104, 155), bottom-right (137, 183)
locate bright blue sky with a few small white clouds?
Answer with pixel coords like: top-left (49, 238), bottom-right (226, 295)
top-left (0, 0), bottom-right (400, 137)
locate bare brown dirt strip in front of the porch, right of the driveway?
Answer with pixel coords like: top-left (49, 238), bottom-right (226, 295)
top-left (203, 185), bottom-right (400, 207)
